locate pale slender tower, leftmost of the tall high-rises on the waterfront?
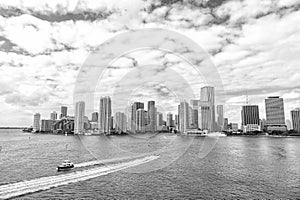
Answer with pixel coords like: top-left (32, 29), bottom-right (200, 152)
top-left (74, 101), bottom-right (85, 134)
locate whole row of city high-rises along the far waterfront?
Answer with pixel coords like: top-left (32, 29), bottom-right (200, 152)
top-left (29, 86), bottom-right (300, 134)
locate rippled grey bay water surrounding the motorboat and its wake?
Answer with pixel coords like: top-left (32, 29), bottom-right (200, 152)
top-left (0, 130), bottom-right (300, 199)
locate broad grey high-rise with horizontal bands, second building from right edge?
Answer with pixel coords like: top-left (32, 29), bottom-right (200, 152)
top-left (265, 96), bottom-right (286, 131)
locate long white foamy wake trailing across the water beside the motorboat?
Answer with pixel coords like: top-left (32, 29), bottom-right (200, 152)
top-left (0, 156), bottom-right (159, 199)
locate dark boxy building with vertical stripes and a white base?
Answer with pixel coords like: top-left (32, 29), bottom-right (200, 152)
top-left (241, 105), bottom-right (260, 132)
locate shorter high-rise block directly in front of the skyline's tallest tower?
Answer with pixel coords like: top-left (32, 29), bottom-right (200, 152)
top-left (198, 101), bottom-right (214, 132)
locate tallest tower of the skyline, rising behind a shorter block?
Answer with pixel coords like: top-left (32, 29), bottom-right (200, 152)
top-left (200, 86), bottom-right (216, 131)
